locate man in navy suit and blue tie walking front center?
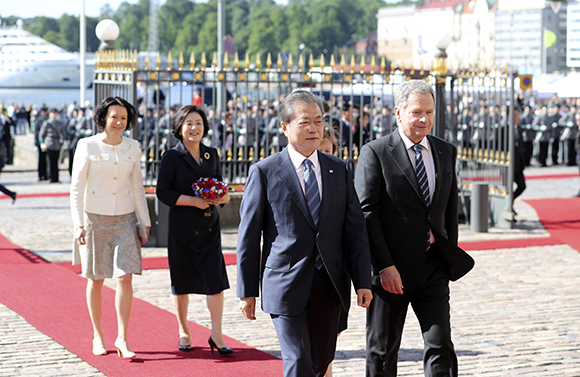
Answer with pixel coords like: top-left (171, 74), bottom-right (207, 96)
top-left (237, 90), bottom-right (372, 377)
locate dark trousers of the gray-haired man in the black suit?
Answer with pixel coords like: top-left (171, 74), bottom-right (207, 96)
top-left (366, 247), bottom-right (457, 377)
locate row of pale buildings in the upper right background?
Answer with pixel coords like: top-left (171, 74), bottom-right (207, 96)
top-left (377, 0), bottom-right (580, 75)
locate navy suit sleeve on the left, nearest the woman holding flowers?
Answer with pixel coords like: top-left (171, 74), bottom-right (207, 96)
top-left (236, 165), bottom-right (267, 297)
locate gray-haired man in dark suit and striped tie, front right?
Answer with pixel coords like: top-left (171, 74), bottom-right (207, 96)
top-left (355, 80), bottom-right (472, 377)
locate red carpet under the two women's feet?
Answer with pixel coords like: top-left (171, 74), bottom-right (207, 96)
top-left (0, 235), bottom-right (282, 377)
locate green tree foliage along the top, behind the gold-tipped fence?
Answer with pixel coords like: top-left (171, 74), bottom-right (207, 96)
top-left (4, 0), bottom-right (390, 58)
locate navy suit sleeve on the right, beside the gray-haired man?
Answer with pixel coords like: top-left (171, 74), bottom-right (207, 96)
top-left (343, 165), bottom-right (371, 289)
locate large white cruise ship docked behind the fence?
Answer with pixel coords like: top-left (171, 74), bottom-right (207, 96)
top-left (0, 19), bottom-right (94, 89)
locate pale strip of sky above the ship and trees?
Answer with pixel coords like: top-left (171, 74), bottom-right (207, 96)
top-left (0, 0), bottom-right (288, 18)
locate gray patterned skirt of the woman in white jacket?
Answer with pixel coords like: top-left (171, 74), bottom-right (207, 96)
top-left (73, 212), bottom-right (141, 280)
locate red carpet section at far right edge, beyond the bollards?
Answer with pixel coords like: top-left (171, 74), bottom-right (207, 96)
top-left (525, 198), bottom-right (580, 251)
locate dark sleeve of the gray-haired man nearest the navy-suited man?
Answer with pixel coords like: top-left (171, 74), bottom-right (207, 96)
top-left (355, 145), bottom-right (395, 273)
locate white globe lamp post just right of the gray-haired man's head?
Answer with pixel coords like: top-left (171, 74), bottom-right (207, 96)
top-left (435, 33), bottom-right (453, 139)
